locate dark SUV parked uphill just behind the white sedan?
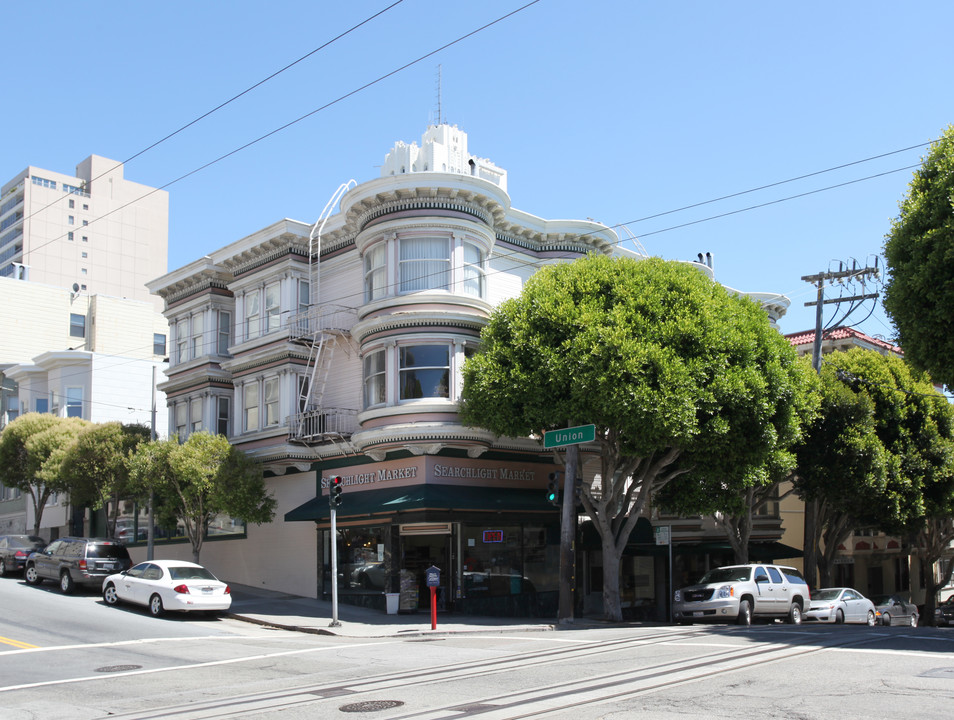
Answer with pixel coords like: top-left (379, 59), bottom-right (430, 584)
top-left (23, 537), bottom-right (132, 593)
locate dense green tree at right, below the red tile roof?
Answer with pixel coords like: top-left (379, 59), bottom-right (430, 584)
top-left (800, 348), bottom-right (954, 623)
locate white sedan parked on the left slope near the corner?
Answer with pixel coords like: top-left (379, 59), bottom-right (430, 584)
top-left (103, 560), bottom-right (232, 617)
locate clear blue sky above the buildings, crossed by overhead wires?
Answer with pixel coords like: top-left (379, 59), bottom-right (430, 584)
top-left (0, 0), bottom-right (954, 337)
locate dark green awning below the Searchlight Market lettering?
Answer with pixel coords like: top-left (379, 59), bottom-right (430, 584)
top-left (285, 483), bottom-right (559, 522)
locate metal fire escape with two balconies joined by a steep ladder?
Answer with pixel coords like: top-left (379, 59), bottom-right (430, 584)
top-left (288, 305), bottom-right (358, 452)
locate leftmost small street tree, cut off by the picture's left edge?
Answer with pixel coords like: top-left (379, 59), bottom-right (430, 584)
top-left (0, 413), bottom-right (88, 535)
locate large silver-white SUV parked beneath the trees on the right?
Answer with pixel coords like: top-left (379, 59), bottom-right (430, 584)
top-left (673, 564), bottom-right (811, 625)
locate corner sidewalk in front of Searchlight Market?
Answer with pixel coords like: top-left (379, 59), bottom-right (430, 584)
top-left (229, 583), bottom-right (592, 638)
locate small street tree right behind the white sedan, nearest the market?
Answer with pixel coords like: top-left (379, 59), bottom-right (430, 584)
top-left (132, 432), bottom-right (276, 562)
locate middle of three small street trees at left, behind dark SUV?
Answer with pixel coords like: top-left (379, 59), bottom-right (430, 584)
top-left (60, 422), bottom-right (150, 536)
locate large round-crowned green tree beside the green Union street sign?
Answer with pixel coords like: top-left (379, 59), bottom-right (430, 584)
top-left (460, 255), bottom-right (799, 620)
